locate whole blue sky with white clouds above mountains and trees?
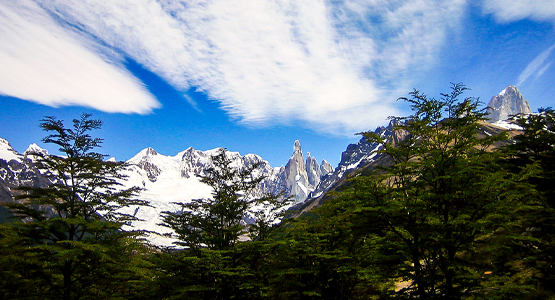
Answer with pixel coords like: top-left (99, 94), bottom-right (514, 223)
top-left (0, 0), bottom-right (555, 166)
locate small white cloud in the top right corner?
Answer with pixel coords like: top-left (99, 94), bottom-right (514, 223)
top-left (483, 0), bottom-right (555, 22)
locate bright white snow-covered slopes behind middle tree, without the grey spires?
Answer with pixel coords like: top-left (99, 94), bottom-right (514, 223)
top-left (122, 148), bottom-right (286, 246)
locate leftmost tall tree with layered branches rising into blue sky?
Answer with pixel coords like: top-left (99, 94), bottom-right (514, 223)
top-left (1, 114), bottom-right (147, 299)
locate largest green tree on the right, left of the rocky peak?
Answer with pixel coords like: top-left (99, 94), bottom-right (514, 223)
top-left (339, 84), bottom-right (536, 299)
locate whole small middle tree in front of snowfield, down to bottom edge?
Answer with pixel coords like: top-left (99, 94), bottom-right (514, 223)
top-left (155, 149), bottom-right (287, 299)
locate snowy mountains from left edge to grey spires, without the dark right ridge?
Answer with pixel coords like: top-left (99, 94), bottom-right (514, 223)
top-left (0, 139), bottom-right (333, 246)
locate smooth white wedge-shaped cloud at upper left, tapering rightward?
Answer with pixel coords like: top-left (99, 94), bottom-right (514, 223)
top-left (0, 1), bottom-right (160, 114)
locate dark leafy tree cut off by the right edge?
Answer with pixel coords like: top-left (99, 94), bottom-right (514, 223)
top-left (506, 108), bottom-right (555, 292)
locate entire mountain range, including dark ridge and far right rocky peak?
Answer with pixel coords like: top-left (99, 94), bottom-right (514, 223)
top-left (0, 86), bottom-right (531, 245)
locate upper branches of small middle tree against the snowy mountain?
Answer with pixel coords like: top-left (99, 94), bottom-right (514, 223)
top-left (162, 149), bottom-right (288, 255)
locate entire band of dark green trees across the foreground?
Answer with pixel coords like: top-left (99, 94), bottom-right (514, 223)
top-left (0, 84), bottom-right (555, 299)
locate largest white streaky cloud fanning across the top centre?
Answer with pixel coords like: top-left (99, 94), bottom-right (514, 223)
top-left (0, 0), bottom-right (466, 135)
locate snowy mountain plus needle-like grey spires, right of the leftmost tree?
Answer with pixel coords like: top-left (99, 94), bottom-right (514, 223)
top-left (122, 141), bottom-right (331, 245)
